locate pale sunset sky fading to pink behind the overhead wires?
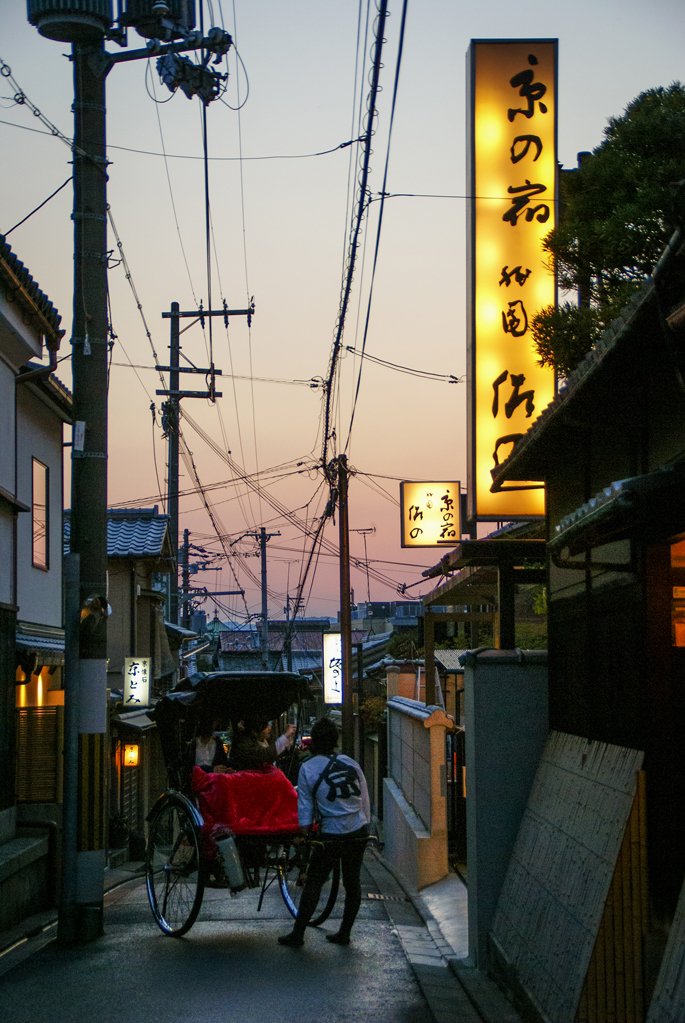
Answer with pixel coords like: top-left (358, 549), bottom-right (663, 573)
top-left (0, 0), bottom-right (685, 620)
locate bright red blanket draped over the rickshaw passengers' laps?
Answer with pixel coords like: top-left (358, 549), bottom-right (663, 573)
top-left (192, 767), bottom-right (299, 835)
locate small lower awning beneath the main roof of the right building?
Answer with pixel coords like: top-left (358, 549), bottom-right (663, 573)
top-left (548, 464), bottom-right (685, 567)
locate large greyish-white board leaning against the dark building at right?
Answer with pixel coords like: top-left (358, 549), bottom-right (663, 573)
top-left (491, 731), bottom-right (643, 1023)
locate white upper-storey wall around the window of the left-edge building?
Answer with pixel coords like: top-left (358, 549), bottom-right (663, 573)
top-left (16, 385), bottom-right (62, 626)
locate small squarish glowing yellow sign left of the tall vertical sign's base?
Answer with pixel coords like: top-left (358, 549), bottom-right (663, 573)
top-left (400, 481), bottom-right (461, 547)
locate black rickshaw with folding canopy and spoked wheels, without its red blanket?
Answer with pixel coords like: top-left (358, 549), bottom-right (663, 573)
top-left (145, 671), bottom-right (339, 937)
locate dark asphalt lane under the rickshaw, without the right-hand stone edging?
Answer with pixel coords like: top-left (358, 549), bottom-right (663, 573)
top-left (0, 852), bottom-right (433, 1023)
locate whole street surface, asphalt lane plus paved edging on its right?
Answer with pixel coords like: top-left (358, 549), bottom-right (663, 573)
top-left (0, 849), bottom-right (518, 1023)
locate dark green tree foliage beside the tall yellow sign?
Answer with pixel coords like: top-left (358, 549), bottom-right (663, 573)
top-left (533, 82), bottom-right (685, 374)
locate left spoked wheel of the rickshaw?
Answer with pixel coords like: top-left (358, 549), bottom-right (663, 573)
top-left (145, 800), bottom-right (204, 938)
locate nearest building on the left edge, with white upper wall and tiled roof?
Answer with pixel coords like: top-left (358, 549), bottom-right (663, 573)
top-left (0, 236), bottom-right (72, 928)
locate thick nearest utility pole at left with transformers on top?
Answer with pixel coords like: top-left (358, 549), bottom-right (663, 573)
top-left (29, 0), bottom-right (231, 942)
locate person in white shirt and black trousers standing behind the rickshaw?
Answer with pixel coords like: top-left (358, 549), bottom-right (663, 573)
top-left (278, 717), bottom-right (371, 948)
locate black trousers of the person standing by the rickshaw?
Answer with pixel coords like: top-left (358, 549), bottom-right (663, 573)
top-left (293, 825), bottom-right (369, 936)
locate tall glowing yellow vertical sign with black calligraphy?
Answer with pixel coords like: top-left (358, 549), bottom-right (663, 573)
top-left (467, 40), bottom-right (557, 521)
